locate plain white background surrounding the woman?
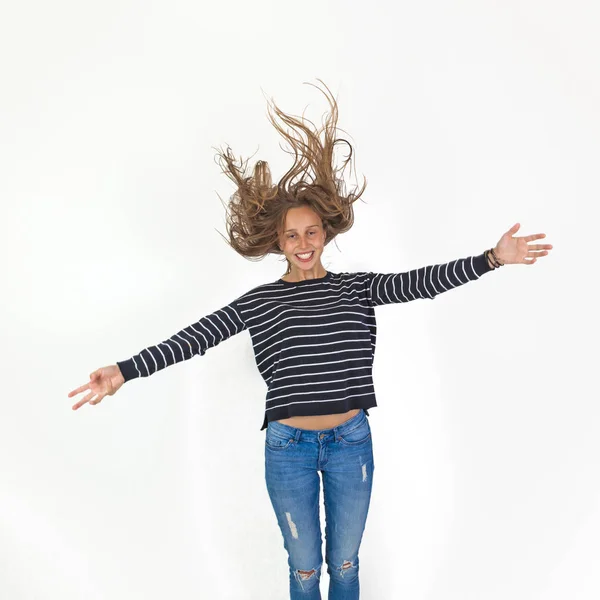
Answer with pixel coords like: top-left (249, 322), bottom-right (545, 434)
top-left (0, 0), bottom-right (600, 600)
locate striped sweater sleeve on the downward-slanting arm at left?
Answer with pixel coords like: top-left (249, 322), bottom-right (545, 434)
top-left (117, 298), bottom-right (247, 381)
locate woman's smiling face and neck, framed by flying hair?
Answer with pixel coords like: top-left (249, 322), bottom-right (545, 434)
top-left (279, 206), bottom-right (326, 281)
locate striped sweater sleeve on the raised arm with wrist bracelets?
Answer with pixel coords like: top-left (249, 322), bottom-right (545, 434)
top-left (367, 253), bottom-right (494, 306)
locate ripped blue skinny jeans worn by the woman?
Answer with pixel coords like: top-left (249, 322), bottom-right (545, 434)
top-left (265, 409), bottom-right (375, 600)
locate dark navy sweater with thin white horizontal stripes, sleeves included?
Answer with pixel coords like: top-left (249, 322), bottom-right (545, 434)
top-left (117, 253), bottom-right (492, 431)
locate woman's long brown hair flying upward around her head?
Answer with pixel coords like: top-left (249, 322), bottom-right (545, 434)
top-left (217, 79), bottom-right (367, 274)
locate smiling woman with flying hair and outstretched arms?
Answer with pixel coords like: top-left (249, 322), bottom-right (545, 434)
top-left (69, 82), bottom-right (552, 600)
